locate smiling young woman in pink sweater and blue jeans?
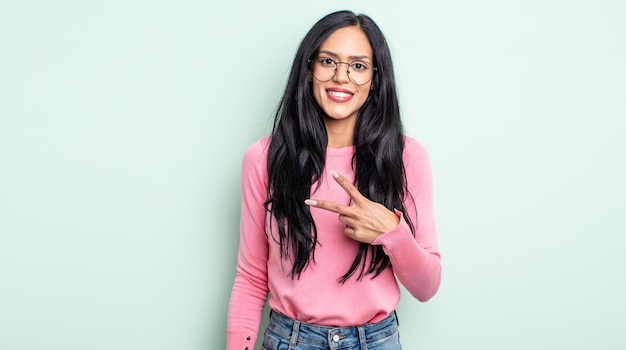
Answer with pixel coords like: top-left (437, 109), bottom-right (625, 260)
top-left (227, 11), bottom-right (441, 350)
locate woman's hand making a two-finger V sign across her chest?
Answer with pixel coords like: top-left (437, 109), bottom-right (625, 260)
top-left (304, 170), bottom-right (400, 244)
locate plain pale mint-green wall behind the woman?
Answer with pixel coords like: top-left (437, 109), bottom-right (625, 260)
top-left (0, 0), bottom-right (626, 350)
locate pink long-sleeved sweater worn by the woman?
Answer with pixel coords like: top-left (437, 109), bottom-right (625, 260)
top-left (227, 137), bottom-right (441, 350)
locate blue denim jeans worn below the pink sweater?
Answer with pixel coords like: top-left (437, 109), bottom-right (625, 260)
top-left (262, 311), bottom-right (402, 350)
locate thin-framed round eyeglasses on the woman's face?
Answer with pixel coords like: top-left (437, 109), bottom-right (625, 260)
top-left (309, 56), bottom-right (378, 85)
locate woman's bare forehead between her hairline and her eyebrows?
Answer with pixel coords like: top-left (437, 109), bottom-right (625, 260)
top-left (320, 26), bottom-right (373, 59)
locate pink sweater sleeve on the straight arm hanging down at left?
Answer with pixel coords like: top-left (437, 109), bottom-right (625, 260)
top-left (226, 140), bottom-right (268, 350)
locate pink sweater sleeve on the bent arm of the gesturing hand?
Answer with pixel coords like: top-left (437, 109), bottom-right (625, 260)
top-left (372, 137), bottom-right (441, 301)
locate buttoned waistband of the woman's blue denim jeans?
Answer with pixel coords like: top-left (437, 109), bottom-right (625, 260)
top-left (266, 310), bottom-right (398, 349)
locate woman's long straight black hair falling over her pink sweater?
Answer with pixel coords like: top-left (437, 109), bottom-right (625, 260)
top-left (265, 11), bottom-right (414, 283)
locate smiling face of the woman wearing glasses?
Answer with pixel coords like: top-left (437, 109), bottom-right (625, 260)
top-left (310, 26), bottom-right (374, 124)
